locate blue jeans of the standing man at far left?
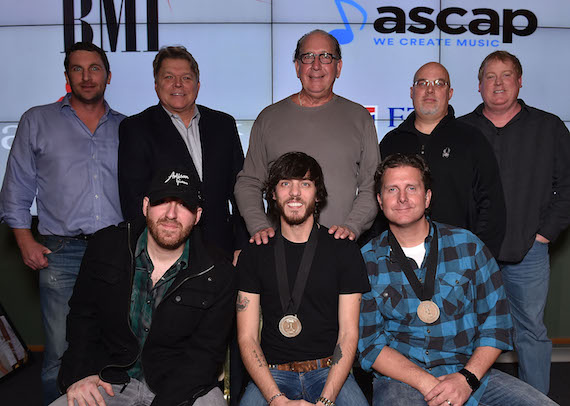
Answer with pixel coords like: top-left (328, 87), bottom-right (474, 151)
top-left (40, 235), bottom-right (87, 405)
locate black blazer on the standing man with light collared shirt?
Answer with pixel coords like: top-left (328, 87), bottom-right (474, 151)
top-left (119, 104), bottom-right (249, 255)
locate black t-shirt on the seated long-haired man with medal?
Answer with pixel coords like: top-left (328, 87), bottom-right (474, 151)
top-left (237, 226), bottom-right (370, 364)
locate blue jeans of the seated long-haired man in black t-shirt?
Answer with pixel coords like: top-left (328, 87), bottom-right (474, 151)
top-left (240, 368), bottom-right (368, 406)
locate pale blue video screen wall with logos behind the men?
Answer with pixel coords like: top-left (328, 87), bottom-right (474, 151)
top-left (0, 0), bottom-right (570, 209)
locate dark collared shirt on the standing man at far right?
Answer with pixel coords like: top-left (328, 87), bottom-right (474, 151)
top-left (459, 99), bottom-right (570, 262)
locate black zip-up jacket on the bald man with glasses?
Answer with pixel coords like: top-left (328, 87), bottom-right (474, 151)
top-left (380, 106), bottom-right (506, 257)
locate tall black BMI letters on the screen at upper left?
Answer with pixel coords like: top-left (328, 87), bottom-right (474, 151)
top-left (63, 0), bottom-right (158, 52)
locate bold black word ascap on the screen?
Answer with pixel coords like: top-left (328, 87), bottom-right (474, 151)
top-left (374, 7), bottom-right (538, 43)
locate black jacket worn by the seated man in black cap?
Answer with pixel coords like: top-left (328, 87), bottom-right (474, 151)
top-left (59, 218), bottom-right (236, 406)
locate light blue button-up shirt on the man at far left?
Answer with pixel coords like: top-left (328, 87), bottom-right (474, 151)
top-left (0, 94), bottom-right (125, 236)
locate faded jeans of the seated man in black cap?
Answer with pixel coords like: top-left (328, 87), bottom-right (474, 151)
top-left (50, 377), bottom-right (228, 406)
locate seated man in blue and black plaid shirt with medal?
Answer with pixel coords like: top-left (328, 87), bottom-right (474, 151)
top-left (358, 154), bottom-right (555, 406)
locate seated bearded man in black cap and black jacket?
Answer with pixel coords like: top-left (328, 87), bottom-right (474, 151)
top-left (53, 169), bottom-right (236, 406)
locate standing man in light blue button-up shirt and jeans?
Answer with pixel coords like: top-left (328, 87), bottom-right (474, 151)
top-left (0, 42), bottom-right (124, 404)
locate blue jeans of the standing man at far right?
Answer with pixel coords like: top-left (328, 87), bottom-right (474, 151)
top-left (501, 241), bottom-right (552, 394)
